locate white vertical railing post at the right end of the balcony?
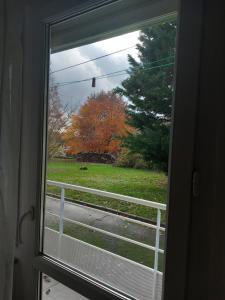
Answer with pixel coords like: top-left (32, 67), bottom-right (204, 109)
top-left (152, 208), bottom-right (161, 300)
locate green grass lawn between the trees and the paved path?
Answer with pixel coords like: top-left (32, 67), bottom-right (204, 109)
top-left (47, 160), bottom-right (167, 222)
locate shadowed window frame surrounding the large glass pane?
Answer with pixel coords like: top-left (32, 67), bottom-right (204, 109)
top-left (11, 0), bottom-right (201, 300)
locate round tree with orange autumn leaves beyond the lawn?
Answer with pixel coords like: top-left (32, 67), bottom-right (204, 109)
top-left (64, 92), bottom-right (133, 154)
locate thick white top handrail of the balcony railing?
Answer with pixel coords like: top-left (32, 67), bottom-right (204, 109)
top-left (47, 180), bottom-right (166, 210)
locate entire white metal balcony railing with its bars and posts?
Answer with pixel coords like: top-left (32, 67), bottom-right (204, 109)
top-left (47, 180), bottom-right (166, 299)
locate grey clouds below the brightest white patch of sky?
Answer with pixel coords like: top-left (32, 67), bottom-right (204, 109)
top-left (51, 45), bottom-right (136, 108)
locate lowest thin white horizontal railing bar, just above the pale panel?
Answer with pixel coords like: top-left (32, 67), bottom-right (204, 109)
top-left (46, 211), bottom-right (164, 253)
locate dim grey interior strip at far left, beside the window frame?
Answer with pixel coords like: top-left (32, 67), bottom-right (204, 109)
top-left (0, 0), bottom-right (23, 300)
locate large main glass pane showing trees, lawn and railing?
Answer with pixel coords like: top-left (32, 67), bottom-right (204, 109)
top-left (43, 17), bottom-right (176, 300)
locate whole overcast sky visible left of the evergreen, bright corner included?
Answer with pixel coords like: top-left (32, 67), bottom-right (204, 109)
top-left (51, 31), bottom-right (139, 109)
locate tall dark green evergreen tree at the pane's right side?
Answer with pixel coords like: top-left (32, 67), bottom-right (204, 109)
top-left (116, 20), bottom-right (176, 171)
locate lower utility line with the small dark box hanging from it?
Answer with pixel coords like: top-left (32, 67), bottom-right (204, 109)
top-left (55, 62), bottom-right (174, 87)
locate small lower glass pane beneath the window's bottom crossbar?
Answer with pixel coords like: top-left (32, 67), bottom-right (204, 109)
top-left (41, 274), bottom-right (87, 300)
